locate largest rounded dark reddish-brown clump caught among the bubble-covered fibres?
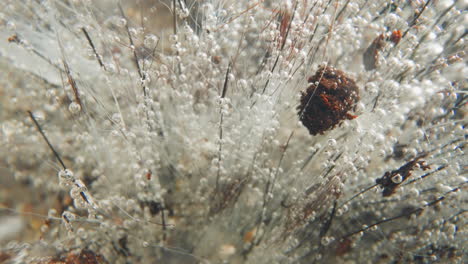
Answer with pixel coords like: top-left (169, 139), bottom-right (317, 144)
top-left (297, 66), bottom-right (359, 135)
